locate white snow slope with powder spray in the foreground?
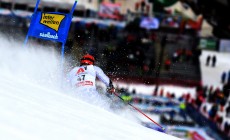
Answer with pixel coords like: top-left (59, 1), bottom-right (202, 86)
top-left (0, 36), bottom-right (179, 140)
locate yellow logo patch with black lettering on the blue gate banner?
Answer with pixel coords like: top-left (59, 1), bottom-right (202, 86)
top-left (40, 13), bottom-right (65, 31)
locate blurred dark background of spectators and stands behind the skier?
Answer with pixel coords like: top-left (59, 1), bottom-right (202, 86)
top-left (0, 0), bottom-right (230, 140)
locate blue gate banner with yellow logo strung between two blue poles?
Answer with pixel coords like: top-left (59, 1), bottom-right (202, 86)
top-left (28, 12), bottom-right (72, 43)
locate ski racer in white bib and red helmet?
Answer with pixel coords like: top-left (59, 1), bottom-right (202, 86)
top-left (68, 54), bottom-right (115, 97)
